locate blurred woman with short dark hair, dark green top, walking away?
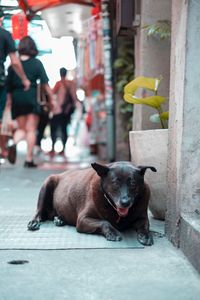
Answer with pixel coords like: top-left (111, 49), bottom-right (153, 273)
top-left (6, 36), bottom-right (53, 168)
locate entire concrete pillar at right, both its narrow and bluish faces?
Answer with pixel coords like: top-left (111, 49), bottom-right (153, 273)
top-left (166, 0), bottom-right (200, 271)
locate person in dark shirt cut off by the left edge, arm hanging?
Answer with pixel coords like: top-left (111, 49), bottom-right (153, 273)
top-left (0, 8), bottom-right (30, 158)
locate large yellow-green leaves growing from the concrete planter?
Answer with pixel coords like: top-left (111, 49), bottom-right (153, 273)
top-left (124, 76), bottom-right (169, 128)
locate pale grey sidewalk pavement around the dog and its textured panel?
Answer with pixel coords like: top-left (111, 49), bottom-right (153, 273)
top-left (0, 144), bottom-right (200, 300)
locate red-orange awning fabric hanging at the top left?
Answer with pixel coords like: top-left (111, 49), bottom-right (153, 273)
top-left (18, 0), bottom-right (94, 20)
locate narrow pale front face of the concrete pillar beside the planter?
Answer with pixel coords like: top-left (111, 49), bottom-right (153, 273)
top-left (166, 0), bottom-right (187, 245)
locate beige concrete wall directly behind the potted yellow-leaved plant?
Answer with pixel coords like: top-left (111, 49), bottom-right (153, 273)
top-left (133, 0), bottom-right (171, 130)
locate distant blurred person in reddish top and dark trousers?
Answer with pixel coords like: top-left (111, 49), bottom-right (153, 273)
top-left (50, 68), bottom-right (78, 156)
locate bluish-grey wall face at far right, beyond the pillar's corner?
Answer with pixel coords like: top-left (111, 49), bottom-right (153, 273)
top-left (181, 1), bottom-right (200, 212)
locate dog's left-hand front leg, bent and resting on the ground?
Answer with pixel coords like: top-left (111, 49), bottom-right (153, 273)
top-left (76, 216), bottom-right (122, 241)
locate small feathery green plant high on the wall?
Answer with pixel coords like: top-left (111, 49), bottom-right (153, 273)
top-left (143, 20), bottom-right (171, 40)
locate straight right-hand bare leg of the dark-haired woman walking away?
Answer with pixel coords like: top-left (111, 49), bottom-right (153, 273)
top-left (26, 114), bottom-right (39, 162)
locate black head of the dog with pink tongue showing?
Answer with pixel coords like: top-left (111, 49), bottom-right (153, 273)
top-left (91, 162), bottom-right (156, 217)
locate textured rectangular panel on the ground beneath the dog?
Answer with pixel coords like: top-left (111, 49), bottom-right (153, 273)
top-left (0, 214), bottom-right (144, 250)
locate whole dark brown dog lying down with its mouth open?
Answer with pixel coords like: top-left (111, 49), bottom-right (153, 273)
top-left (28, 161), bottom-right (156, 246)
